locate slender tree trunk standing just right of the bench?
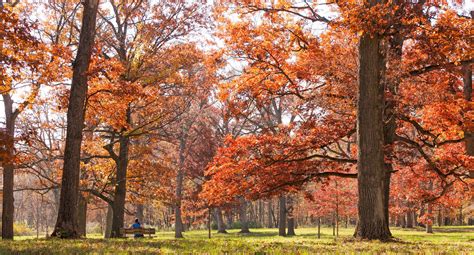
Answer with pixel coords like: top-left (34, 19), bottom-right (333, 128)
top-left (174, 136), bottom-right (186, 238)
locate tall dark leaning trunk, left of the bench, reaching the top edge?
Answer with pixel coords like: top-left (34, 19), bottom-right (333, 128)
top-left (51, 0), bottom-right (99, 238)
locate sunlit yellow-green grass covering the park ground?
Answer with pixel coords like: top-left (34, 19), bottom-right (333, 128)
top-left (0, 226), bottom-right (474, 254)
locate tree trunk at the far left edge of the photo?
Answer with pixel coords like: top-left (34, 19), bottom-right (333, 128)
top-left (2, 94), bottom-right (16, 239)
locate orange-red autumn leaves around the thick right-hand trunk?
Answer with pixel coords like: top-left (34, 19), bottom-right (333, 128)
top-left (202, 1), bottom-right (474, 210)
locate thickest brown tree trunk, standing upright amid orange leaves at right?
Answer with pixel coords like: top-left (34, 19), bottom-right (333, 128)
top-left (354, 0), bottom-right (391, 240)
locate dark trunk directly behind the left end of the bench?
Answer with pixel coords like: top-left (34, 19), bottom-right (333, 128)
top-left (111, 130), bottom-right (130, 238)
